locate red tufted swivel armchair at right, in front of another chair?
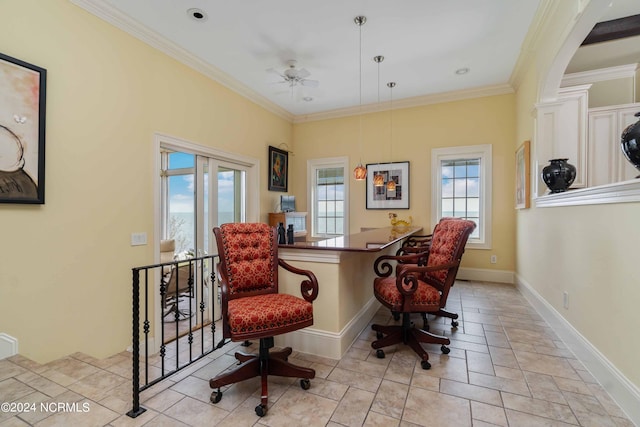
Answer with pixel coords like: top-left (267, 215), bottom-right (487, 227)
top-left (371, 218), bottom-right (476, 369)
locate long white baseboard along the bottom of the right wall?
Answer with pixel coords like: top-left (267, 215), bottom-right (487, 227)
top-left (516, 276), bottom-right (640, 426)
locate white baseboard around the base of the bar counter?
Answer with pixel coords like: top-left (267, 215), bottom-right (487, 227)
top-left (275, 298), bottom-right (381, 360)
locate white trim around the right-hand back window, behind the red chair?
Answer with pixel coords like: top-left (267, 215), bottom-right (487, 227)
top-left (431, 144), bottom-right (492, 249)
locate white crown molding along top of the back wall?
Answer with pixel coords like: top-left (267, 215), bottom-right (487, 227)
top-left (293, 84), bottom-right (514, 123)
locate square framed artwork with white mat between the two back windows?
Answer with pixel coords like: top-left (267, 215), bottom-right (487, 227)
top-left (367, 162), bottom-right (409, 209)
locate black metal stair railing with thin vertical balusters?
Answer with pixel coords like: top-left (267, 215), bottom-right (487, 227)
top-left (127, 255), bottom-right (218, 418)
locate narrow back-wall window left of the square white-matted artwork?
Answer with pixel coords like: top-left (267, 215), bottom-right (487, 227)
top-left (307, 157), bottom-right (349, 237)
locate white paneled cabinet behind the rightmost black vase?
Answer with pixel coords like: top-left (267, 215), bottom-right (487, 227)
top-left (587, 103), bottom-right (640, 187)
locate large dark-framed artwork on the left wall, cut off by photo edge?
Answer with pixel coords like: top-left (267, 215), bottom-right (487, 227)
top-left (0, 53), bottom-right (47, 204)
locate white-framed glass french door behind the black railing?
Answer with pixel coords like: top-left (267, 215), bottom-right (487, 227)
top-left (156, 136), bottom-right (259, 348)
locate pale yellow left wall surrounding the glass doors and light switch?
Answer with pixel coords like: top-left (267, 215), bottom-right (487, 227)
top-left (0, 0), bottom-right (291, 362)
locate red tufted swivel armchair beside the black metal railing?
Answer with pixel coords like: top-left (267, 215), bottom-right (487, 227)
top-left (209, 223), bottom-right (318, 416)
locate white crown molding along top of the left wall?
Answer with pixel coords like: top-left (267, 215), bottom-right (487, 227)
top-left (69, 0), bottom-right (294, 122)
